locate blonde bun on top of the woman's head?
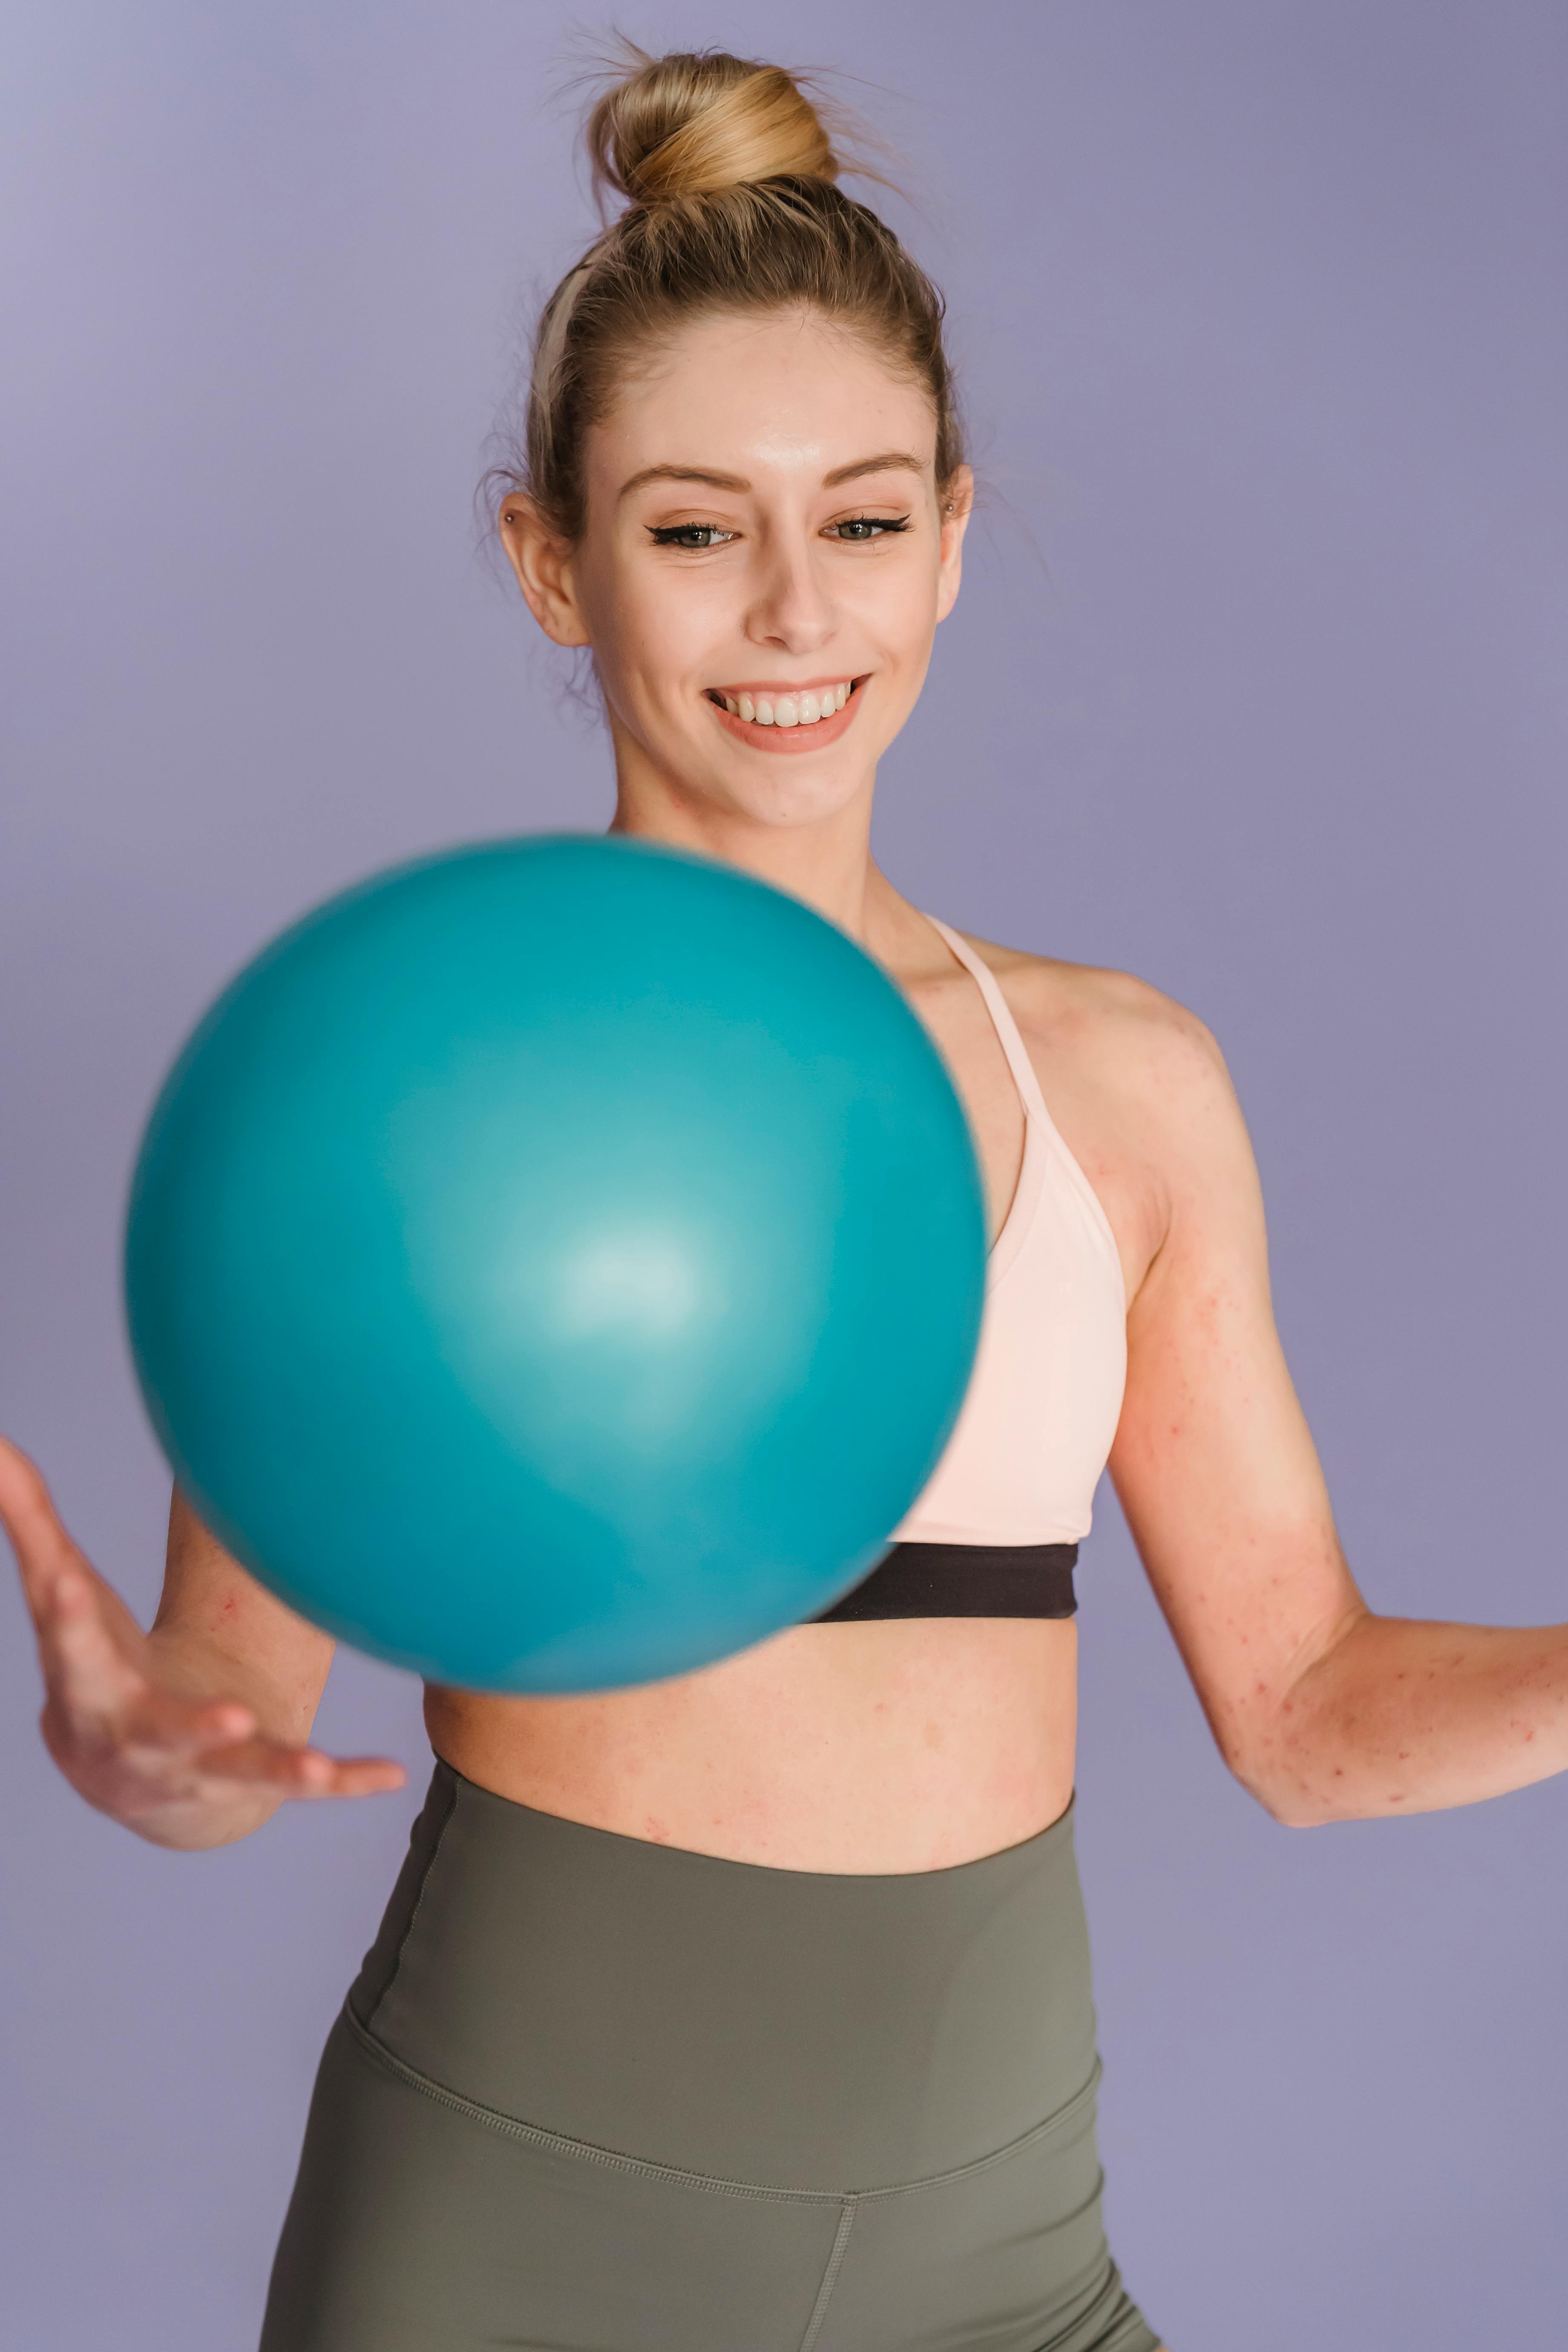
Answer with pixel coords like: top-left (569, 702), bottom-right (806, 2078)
top-left (585, 45), bottom-right (839, 204)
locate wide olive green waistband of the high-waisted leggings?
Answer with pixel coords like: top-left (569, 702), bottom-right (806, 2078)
top-left (348, 1762), bottom-right (1096, 2190)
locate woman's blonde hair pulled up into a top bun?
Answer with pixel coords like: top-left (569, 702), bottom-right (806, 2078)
top-left (486, 42), bottom-right (964, 541)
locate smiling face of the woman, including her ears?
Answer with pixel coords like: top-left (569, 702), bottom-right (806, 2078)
top-left (503, 313), bottom-right (969, 825)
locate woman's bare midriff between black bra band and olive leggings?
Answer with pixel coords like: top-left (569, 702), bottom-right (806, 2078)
top-left (426, 1618), bottom-right (1077, 1872)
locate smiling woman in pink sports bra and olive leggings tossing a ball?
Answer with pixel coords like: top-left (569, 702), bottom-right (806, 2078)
top-left (0, 41), bottom-right (1568, 2352)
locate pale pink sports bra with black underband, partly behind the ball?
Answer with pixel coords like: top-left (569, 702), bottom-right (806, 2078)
top-left (808, 915), bottom-right (1126, 1625)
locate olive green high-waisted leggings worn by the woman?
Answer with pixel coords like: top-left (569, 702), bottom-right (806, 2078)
top-left (261, 1764), bottom-right (1157, 2352)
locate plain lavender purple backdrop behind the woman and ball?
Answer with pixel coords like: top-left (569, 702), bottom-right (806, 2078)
top-left (0, 0), bottom-right (1568, 2352)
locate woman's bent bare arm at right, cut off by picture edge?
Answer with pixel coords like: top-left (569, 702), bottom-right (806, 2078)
top-left (1110, 1000), bottom-right (1568, 1828)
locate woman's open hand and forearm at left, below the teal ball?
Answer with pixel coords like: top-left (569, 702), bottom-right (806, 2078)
top-left (0, 1437), bottom-right (404, 1851)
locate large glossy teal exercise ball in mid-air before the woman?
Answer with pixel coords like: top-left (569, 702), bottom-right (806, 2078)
top-left (124, 835), bottom-right (985, 1691)
